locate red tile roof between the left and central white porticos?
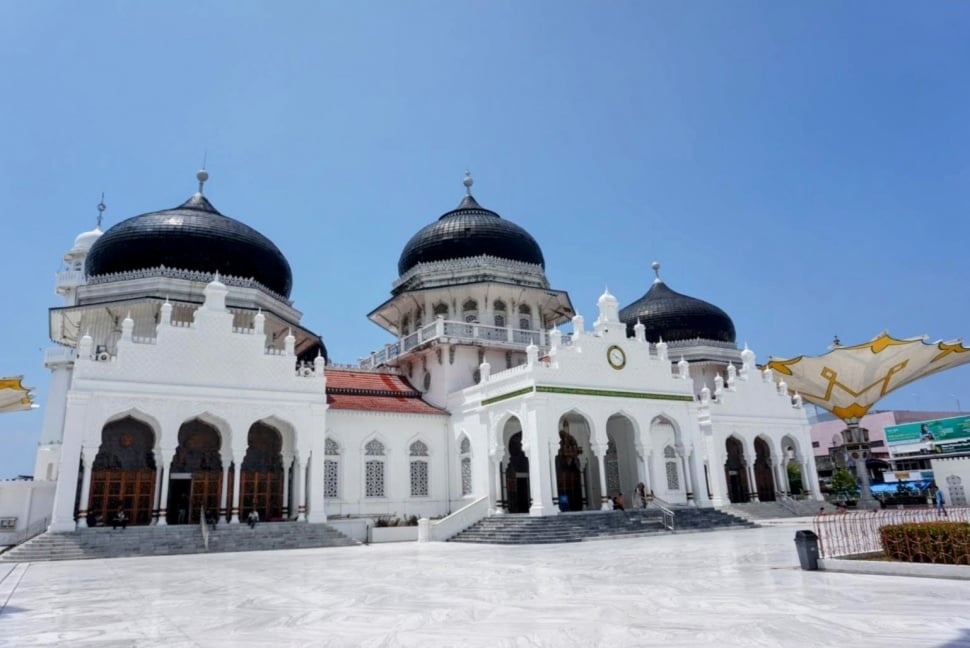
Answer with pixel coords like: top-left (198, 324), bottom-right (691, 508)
top-left (327, 369), bottom-right (448, 416)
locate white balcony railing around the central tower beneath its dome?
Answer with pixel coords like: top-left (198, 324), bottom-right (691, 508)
top-left (360, 319), bottom-right (556, 369)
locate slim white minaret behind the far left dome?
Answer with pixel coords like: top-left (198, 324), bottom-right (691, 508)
top-left (34, 194), bottom-right (107, 481)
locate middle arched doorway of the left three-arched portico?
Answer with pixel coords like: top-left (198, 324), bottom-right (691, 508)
top-left (166, 419), bottom-right (225, 524)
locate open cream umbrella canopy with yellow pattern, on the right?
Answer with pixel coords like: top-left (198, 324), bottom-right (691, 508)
top-left (767, 332), bottom-right (970, 422)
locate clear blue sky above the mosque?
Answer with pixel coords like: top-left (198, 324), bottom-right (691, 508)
top-left (0, 1), bottom-right (970, 477)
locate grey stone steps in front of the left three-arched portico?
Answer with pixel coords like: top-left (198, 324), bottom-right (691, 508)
top-left (0, 522), bottom-right (359, 562)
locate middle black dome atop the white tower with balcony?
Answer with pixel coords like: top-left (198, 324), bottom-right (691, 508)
top-left (397, 190), bottom-right (546, 275)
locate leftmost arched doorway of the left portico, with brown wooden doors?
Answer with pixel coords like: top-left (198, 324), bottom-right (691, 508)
top-left (87, 416), bottom-right (155, 524)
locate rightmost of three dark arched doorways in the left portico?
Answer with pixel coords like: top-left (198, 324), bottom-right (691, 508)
top-left (239, 422), bottom-right (283, 520)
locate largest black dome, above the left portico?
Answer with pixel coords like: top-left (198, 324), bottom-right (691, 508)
top-left (84, 193), bottom-right (293, 298)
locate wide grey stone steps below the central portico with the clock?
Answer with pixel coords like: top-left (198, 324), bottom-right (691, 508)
top-left (449, 508), bottom-right (755, 544)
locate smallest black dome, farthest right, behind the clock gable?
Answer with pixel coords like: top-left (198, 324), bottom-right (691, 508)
top-left (620, 278), bottom-right (735, 343)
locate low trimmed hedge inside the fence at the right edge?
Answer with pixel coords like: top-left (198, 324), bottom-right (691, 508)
top-left (879, 522), bottom-right (970, 565)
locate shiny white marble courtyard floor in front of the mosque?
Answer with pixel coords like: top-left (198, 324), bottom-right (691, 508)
top-left (0, 526), bottom-right (970, 648)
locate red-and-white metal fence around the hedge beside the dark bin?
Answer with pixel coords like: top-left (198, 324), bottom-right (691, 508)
top-left (813, 506), bottom-right (970, 558)
